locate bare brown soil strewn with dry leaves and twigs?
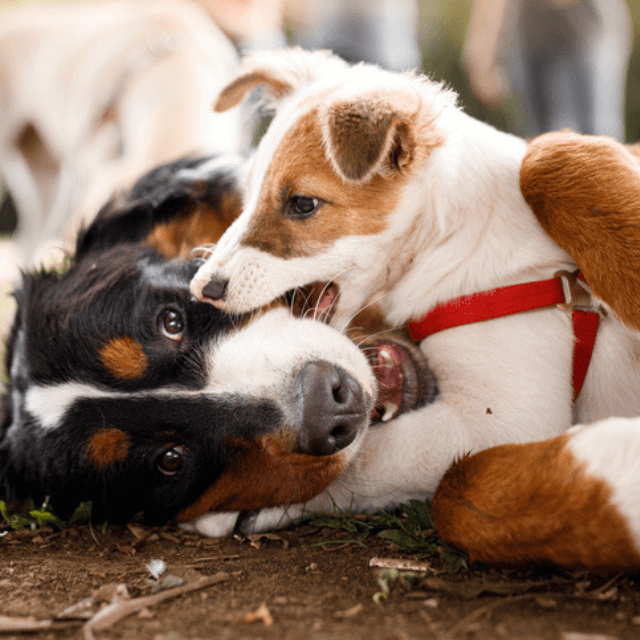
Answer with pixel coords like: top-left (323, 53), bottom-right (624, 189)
top-left (0, 524), bottom-right (640, 640)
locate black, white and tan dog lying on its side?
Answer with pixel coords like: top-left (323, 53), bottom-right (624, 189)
top-left (0, 157), bottom-right (433, 535)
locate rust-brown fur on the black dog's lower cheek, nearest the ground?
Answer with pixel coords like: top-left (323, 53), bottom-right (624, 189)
top-left (176, 435), bottom-right (344, 522)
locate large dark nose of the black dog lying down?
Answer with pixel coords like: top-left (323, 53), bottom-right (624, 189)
top-left (297, 361), bottom-right (368, 456)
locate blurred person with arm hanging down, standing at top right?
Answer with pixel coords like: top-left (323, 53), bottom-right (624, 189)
top-left (463, 0), bottom-right (631, 140)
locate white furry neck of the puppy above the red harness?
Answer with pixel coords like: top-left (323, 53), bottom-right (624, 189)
top-left (336, 111), bottom-right (573, 325)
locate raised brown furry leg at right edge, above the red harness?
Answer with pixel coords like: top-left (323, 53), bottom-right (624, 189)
top-left (520, 132), bottom-right (640, 329)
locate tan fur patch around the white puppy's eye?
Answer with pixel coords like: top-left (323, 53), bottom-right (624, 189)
top-left (242, 110), bottom-right (420, 258)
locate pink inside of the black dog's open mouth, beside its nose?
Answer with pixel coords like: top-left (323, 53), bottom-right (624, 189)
top-left (371, 341), bottom-right (408, 422)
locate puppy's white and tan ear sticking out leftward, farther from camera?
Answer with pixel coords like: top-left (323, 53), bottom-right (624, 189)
top-left (214, 47), bottom-right (348, 112)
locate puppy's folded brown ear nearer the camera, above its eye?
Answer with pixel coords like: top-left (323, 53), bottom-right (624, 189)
top-left (320, 95), bottom-right (434, 182)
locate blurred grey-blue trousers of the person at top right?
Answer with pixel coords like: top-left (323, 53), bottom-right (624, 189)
top-left (514, 0), bottom-right (631, 141)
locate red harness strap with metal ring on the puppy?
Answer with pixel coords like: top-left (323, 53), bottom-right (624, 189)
top-left (409, 271), bottom-right (600, 401)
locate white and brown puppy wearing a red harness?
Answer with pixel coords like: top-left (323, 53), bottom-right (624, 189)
top-left (191, 50), bottom-right (640, 568)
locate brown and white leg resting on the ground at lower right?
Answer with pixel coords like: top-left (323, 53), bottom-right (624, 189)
top-left (432, 418), bottom-right (640, 572)
